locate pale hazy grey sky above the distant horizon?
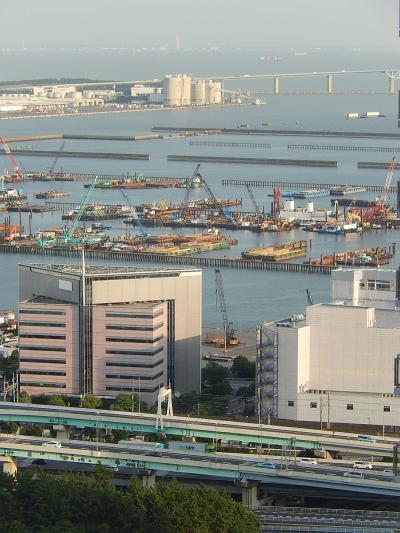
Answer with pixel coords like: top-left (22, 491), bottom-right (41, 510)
top-left (0, 0), bottom-right (400, 48)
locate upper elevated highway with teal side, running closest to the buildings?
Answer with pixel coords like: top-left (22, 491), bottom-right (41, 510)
top-left (0, 402), bottom-right (396, 457)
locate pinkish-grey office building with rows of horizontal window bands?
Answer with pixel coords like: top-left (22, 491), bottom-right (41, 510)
top-left (19, 265), bottom-right (201, 404)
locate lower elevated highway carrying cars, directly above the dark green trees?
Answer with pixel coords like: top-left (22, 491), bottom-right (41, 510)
top-left (0, 435), bottom-right (400, 505)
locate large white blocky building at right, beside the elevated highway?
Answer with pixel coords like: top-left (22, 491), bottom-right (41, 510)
top-left (258, 269), bottom-right (400, 426)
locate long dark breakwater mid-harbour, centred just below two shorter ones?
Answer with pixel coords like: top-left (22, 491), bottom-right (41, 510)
top-left (167, 155), bottom-right (339, 168)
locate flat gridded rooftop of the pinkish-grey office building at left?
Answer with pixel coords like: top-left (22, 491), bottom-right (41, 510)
top-left (18, 263), bottom-right (201, 278)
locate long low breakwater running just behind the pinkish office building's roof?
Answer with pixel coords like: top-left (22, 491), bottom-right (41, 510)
top-left (0, 244), bottom-right (333, 275)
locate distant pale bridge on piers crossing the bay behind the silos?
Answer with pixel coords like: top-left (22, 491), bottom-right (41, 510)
top-left (0, 68), bottom-right (400, 95)
